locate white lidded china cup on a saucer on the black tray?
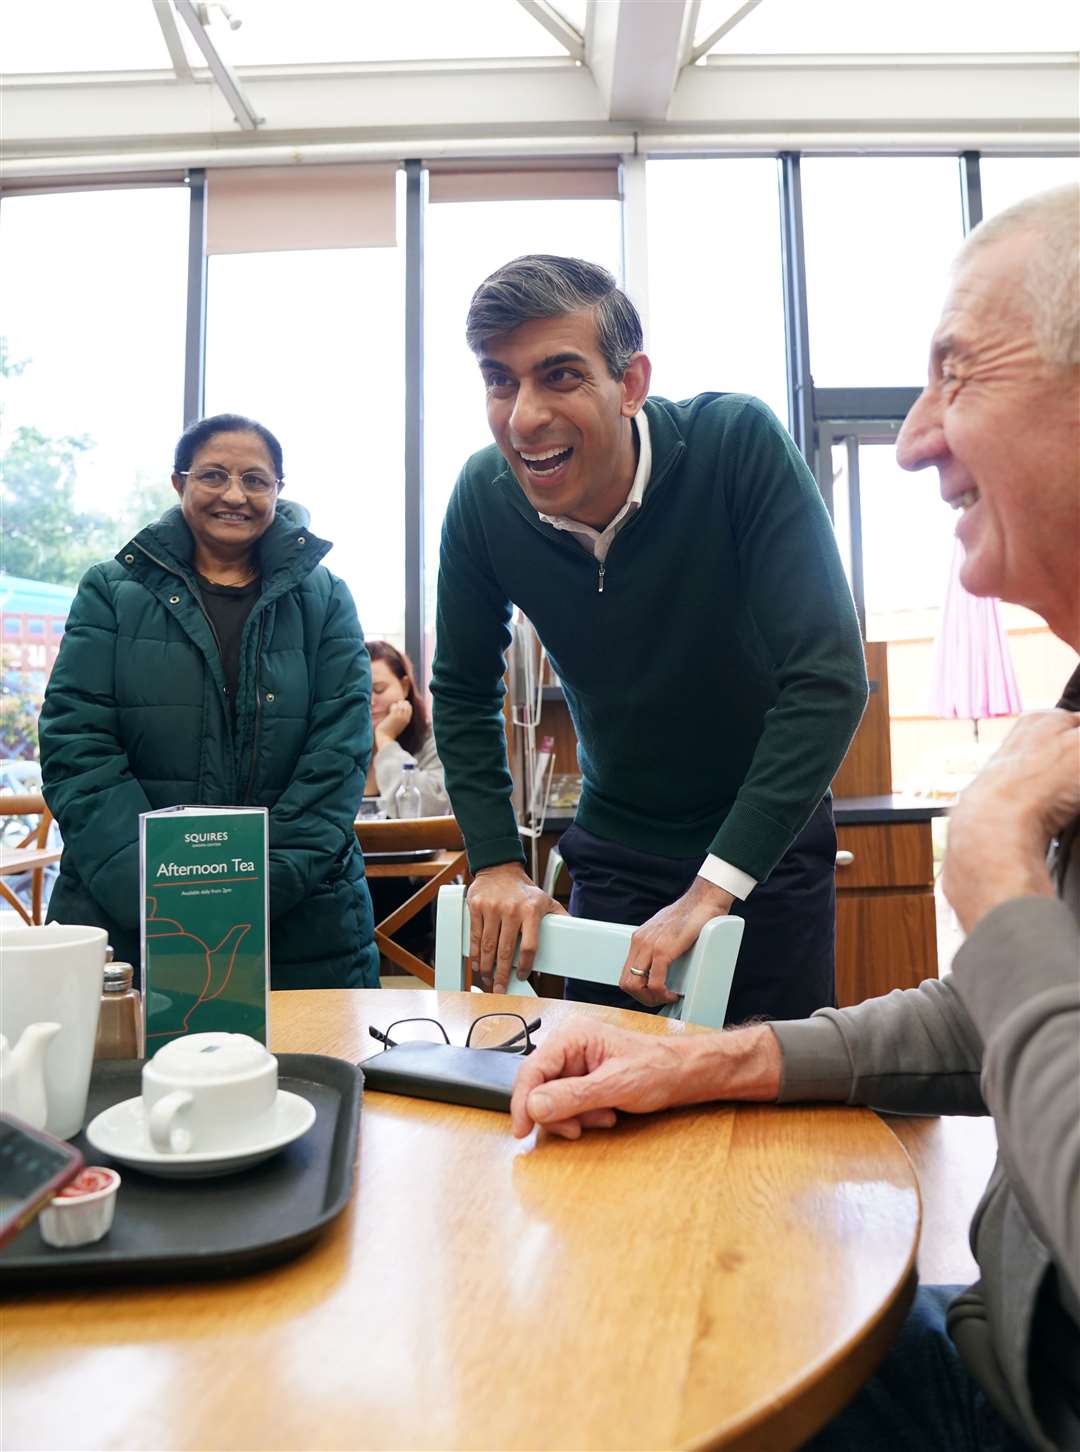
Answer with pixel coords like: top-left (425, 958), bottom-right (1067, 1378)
top-left (142, 1034), bottom-right (277, 1154)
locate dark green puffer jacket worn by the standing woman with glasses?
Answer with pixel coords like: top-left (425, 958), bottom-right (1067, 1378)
top-left (41, 501), bottom-right (379, 989)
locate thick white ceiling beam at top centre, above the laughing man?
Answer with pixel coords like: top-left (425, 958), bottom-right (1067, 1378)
top-left (585, 0), bottom-right (697, 123)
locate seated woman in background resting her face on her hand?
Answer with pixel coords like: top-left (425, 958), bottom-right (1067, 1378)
top-left (364, 640), bottom-right (450, 816)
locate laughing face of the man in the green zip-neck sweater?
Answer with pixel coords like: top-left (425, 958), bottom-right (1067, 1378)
top-left (479, 311), bottom-right (650, 529)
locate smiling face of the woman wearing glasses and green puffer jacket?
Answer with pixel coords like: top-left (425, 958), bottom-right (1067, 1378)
top-left (173, 430), bottom-right (279, 559)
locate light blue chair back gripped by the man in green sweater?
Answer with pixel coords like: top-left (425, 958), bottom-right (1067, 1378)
top-left (435, 883), bottom-right (743, 1028)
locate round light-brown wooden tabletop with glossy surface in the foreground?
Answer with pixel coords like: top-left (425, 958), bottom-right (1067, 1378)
top-left (0, 990), bottom-right (919, 1452)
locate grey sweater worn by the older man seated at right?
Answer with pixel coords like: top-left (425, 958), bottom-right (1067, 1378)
top-left (771, 699), bottom-right (1080, 1449)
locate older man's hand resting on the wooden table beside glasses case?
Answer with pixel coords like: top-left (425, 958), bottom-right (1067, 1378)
top-left (510, 1015), bottom-right (781, 1140)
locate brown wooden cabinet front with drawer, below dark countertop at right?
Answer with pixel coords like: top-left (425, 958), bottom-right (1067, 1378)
top-left (836, 822), bottom-right (938, 1008)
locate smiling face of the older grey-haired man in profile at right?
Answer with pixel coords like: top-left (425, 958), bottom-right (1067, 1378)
top-left (897, 232), bottom-right (1080, 639)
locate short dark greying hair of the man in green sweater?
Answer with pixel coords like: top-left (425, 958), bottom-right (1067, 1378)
top-left (465, 253), bottom-right (645, 379)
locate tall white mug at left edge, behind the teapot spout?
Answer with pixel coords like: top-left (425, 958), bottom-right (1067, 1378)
top-left (0, 922), bottom-right (109, 1140)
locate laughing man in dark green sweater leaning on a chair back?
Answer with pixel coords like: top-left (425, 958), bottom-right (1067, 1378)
top-left (431, 256), bottom-right (867, 1022)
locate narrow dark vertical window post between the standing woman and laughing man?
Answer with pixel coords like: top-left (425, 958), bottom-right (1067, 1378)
top-left (405, 161), bottom-right (430, 676)
